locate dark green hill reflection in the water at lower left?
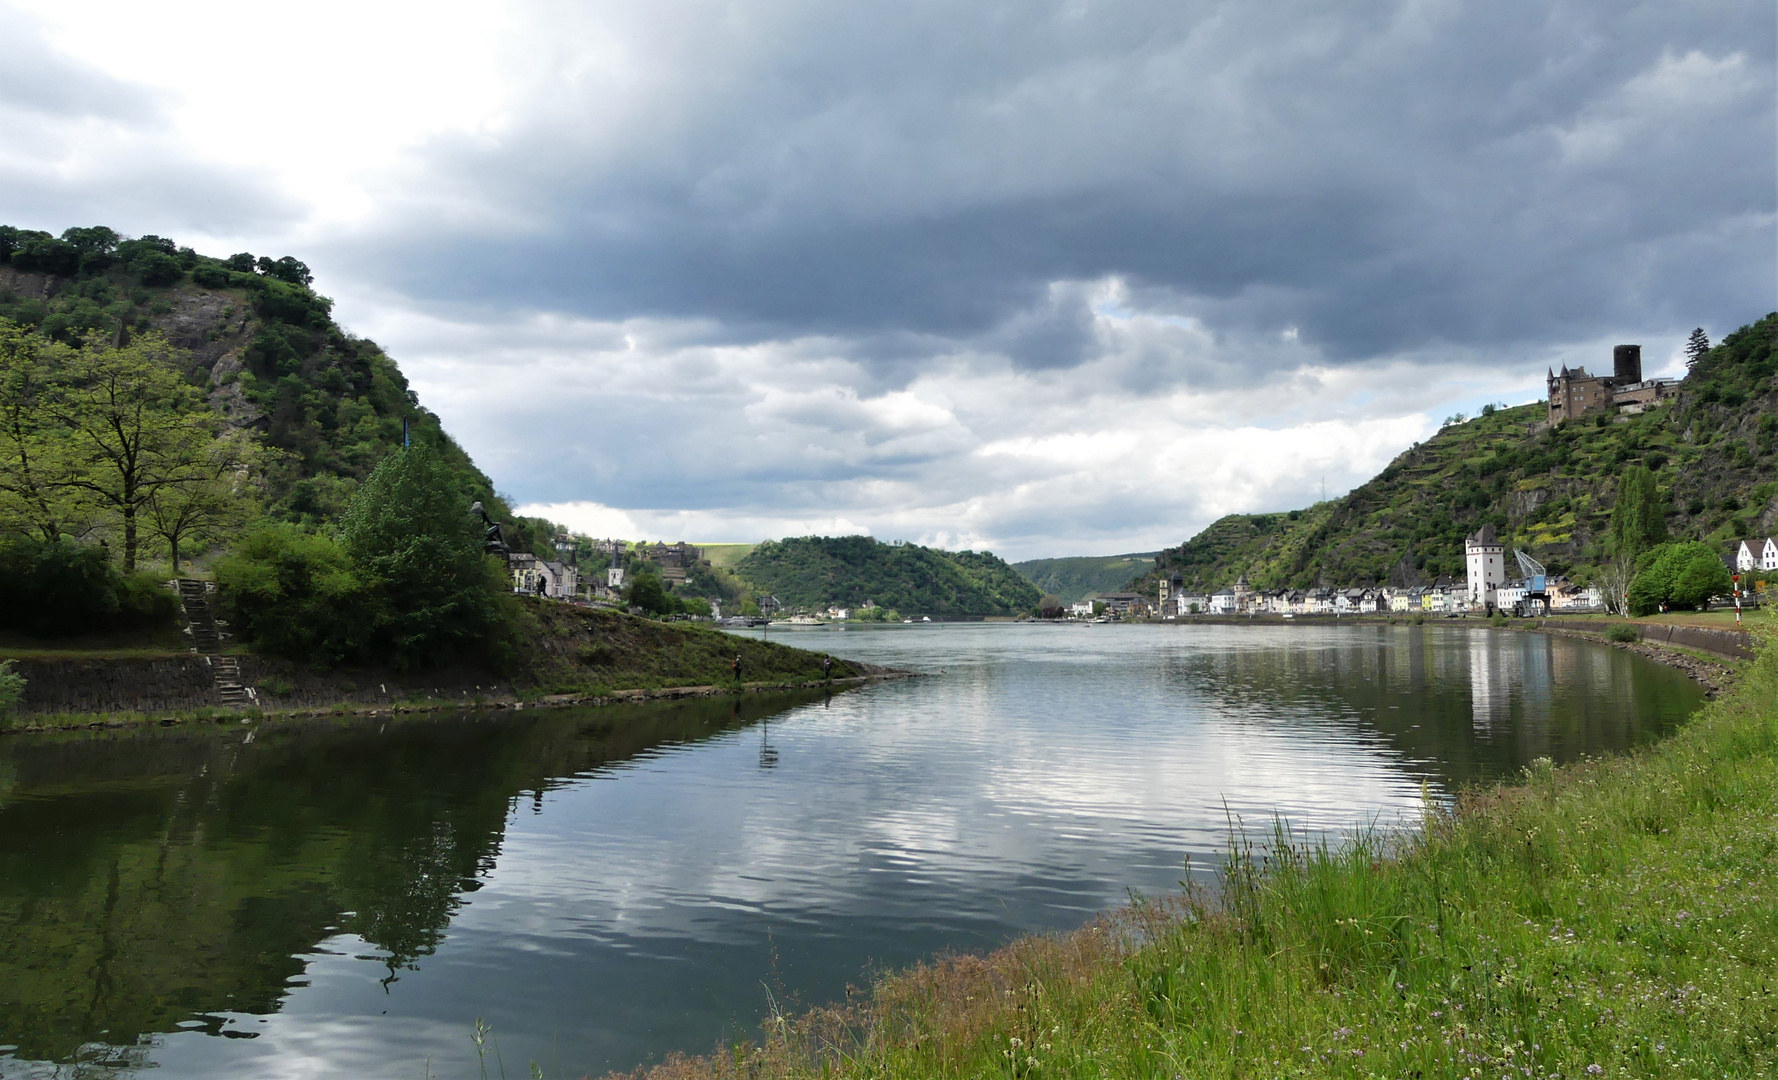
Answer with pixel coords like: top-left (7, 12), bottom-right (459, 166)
top-left (0, 696), bottom-right (807, 1060)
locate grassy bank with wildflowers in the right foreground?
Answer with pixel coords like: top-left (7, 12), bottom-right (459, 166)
top-left (638, 633), bottom-right (1778, 1080)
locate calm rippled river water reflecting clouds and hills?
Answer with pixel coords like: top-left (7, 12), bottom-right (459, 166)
top-left (0, 623), bottom-right (1702, 1078)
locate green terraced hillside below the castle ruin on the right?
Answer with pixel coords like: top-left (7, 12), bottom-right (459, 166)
top-left (1131, 313), bottom-right (1778, 591)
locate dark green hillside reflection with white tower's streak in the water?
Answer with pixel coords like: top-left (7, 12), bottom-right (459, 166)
top-left (1166, 626), bottom-right (1702, 783)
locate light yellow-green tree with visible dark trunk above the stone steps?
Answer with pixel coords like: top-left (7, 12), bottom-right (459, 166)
top-left (46, 334), bottom-right (215, 573)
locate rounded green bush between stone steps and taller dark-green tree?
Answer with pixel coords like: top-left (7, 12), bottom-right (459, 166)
top-left (217, 525), bottom-right (375, 667)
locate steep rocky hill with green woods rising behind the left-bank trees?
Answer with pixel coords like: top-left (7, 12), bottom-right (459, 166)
top-left (0, 226), bottom-right (547, 555)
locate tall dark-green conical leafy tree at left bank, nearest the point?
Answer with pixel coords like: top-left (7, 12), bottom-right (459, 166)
top-left (341, 445), bottom-right (509, 667)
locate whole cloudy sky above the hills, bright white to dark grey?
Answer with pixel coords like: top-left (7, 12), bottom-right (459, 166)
top-left (0, 0), bottom-right (1778, 559)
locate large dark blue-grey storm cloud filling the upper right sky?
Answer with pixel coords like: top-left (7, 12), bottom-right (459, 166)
top-left (339, 0), bottom-right (1778, 368)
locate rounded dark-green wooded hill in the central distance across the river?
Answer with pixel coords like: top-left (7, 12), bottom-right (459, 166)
top-left (734, 536), bottom-right (1042, 616)
